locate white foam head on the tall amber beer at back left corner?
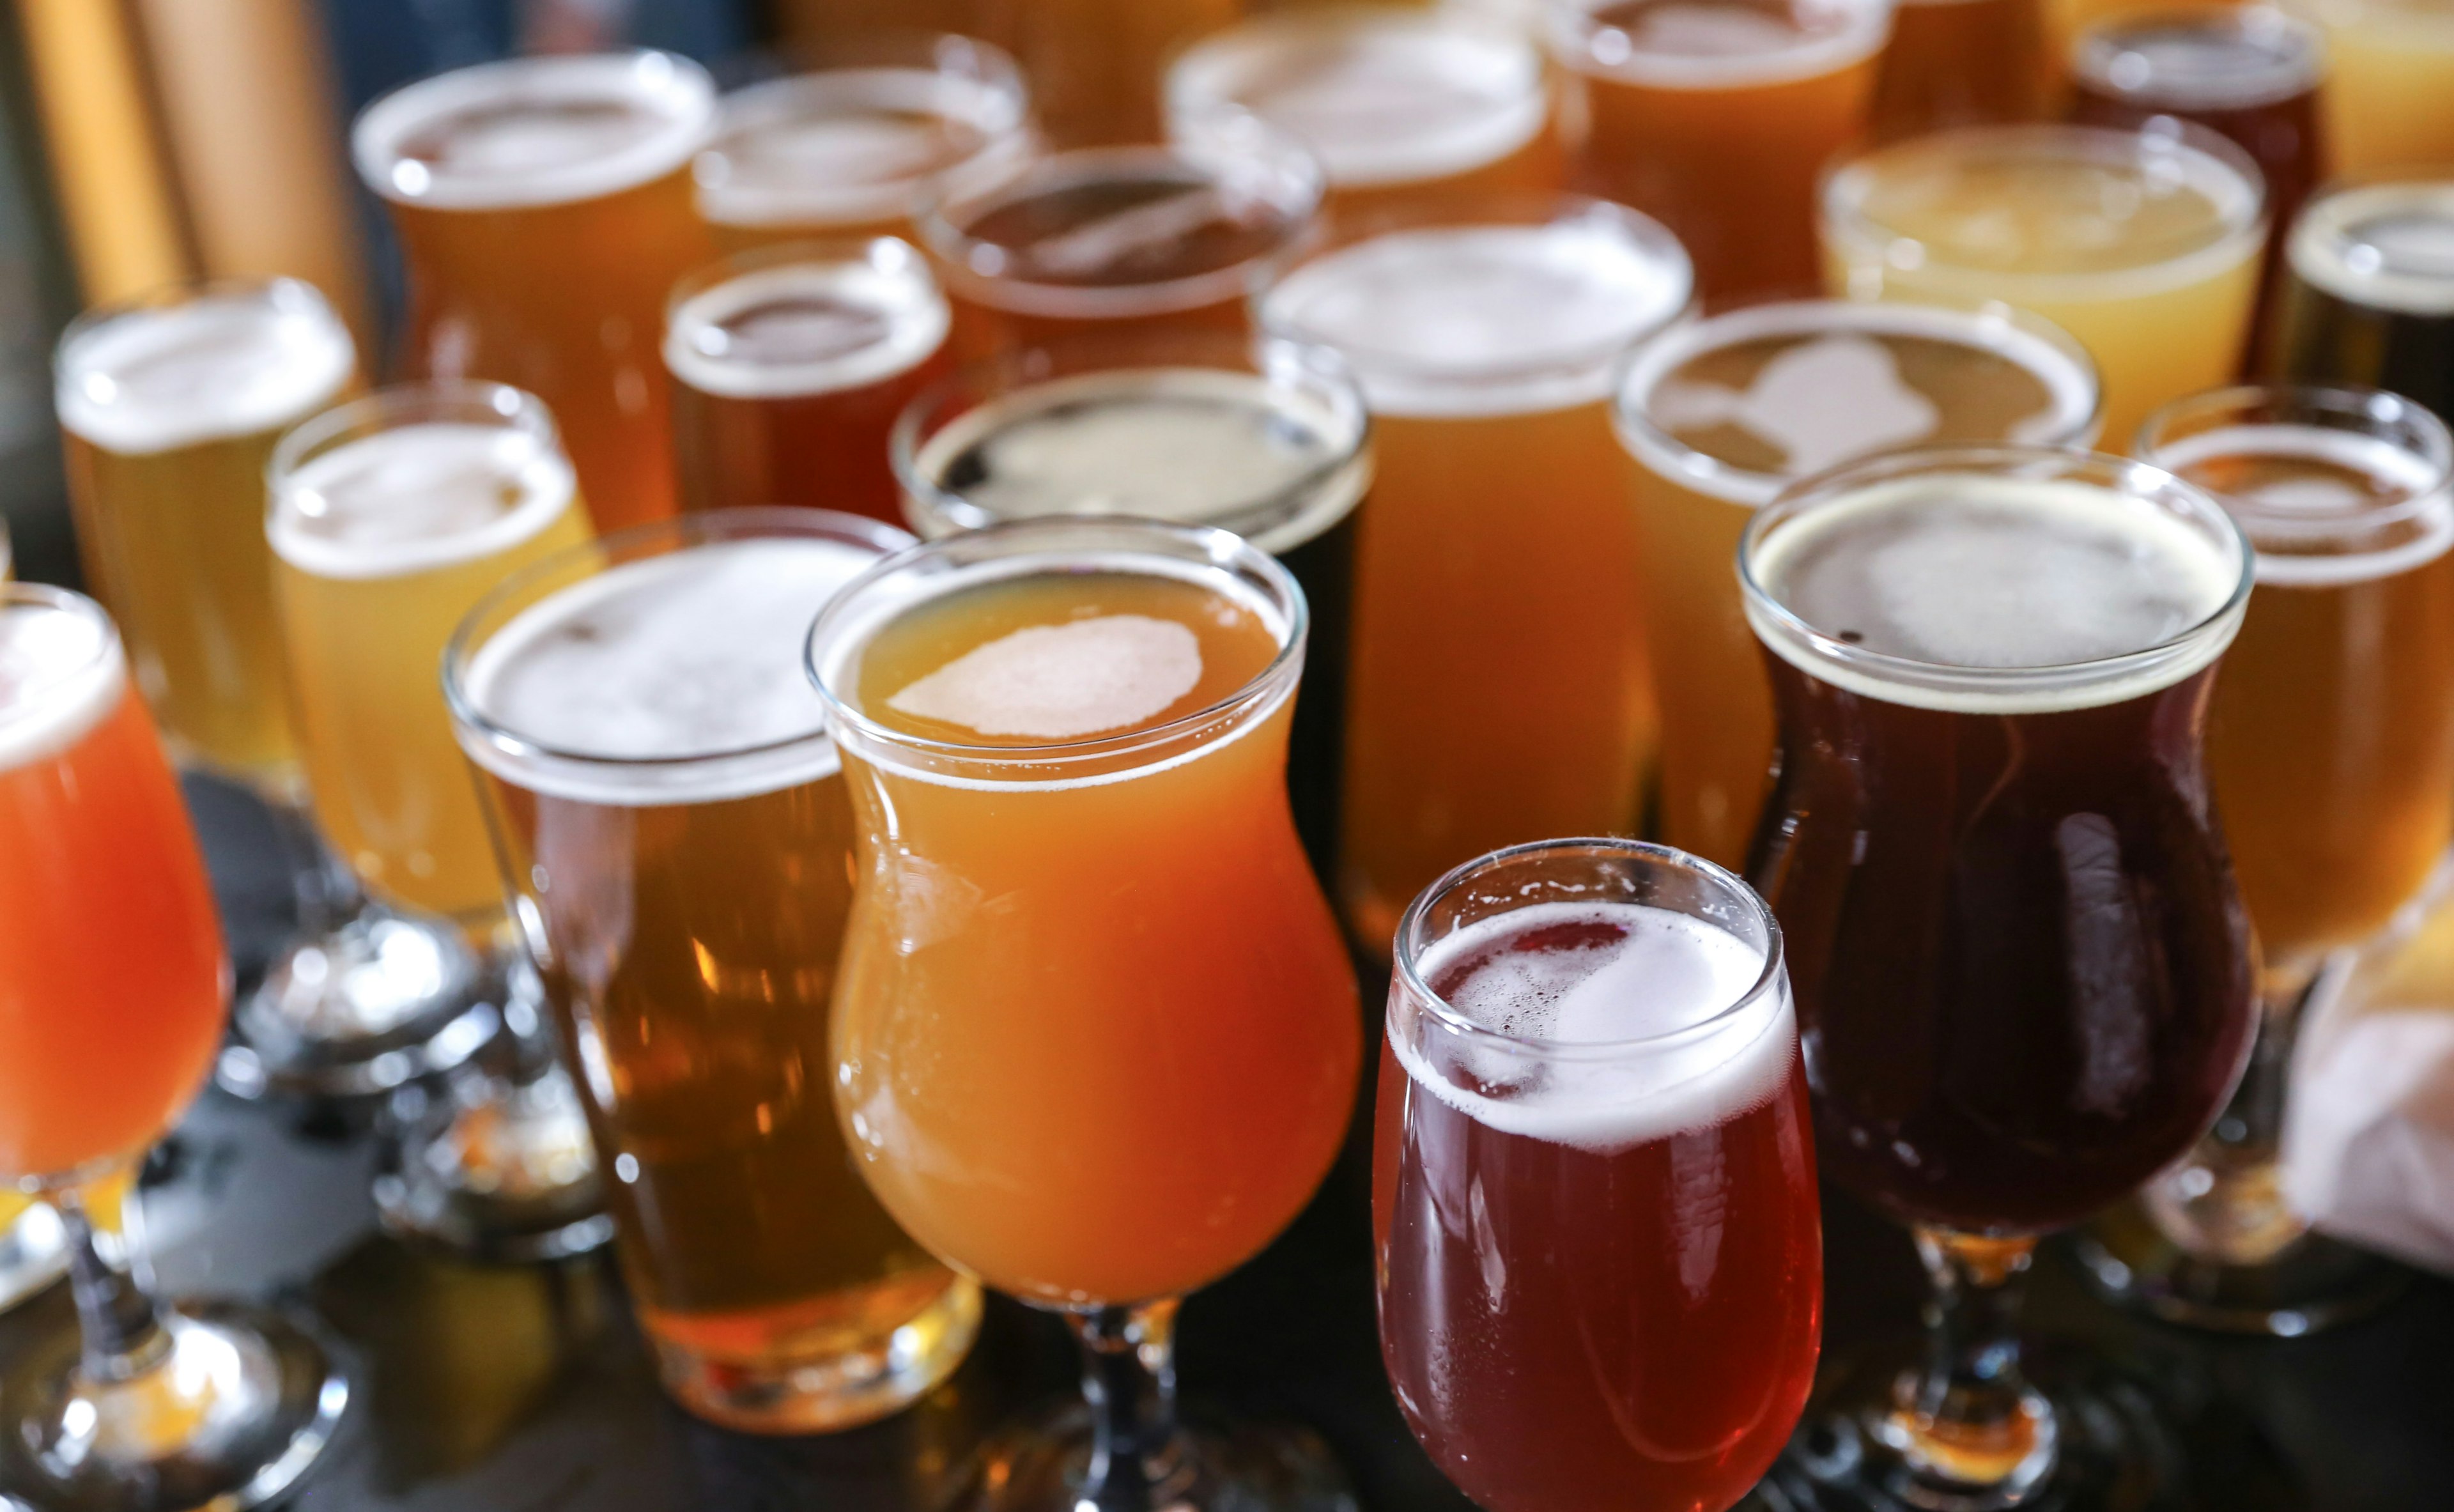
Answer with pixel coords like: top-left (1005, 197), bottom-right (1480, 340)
top-left (351, 52), bottom-right (716, 211)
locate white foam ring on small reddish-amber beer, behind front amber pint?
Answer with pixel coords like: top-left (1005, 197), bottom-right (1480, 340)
top-left (665, 236), bottom-right (952, 400)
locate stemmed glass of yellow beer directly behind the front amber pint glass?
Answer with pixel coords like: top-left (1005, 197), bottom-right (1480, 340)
top-left (265, 383), bottom-right (606, 1254)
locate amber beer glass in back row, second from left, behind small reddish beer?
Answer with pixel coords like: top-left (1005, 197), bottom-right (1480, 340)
top-left (692, 35), bottom-right (1033, 253)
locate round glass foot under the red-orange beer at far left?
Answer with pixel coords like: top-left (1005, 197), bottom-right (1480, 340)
top-left (0, 1304), bottom-right (348, 1512)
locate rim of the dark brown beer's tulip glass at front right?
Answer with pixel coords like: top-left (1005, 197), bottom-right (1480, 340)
top-left (1738, 436), bottom-right (2258, 707)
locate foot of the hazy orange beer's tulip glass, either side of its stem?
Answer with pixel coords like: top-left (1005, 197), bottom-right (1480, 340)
top-left (943, 1401), bottom-right (1355, 1512)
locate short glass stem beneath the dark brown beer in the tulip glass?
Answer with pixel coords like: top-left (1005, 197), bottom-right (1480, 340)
top-left (1887, 1227), bottom-right (2054, 1492)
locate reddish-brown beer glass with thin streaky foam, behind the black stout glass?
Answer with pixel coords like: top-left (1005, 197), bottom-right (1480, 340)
top-left (920, 116), bottom-right (1320, 359)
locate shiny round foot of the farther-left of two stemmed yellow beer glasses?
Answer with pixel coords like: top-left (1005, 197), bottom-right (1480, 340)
top-left (213, 903), bottom-right (500, 1100)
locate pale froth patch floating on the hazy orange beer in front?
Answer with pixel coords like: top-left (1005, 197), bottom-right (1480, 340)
top-left (886, 613), bottom-right (1203, 741)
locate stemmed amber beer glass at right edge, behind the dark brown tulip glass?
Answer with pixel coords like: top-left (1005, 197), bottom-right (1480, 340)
top-left (2091, 385), bottom-right (2454, 1335)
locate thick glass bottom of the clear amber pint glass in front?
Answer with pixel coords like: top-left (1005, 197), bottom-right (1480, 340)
top-left (662, 1269), bottom-right (979, 1433)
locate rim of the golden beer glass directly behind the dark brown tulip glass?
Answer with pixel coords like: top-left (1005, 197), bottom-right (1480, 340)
top-left (1610, 300), bottom-right (2106, 508)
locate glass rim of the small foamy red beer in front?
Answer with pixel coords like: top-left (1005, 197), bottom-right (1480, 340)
top-left (1389, 835), bottom-right (1787, 1060)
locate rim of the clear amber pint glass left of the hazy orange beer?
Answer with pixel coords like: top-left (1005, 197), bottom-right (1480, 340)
top-left (442, 503), bottom-right (911, 771)
